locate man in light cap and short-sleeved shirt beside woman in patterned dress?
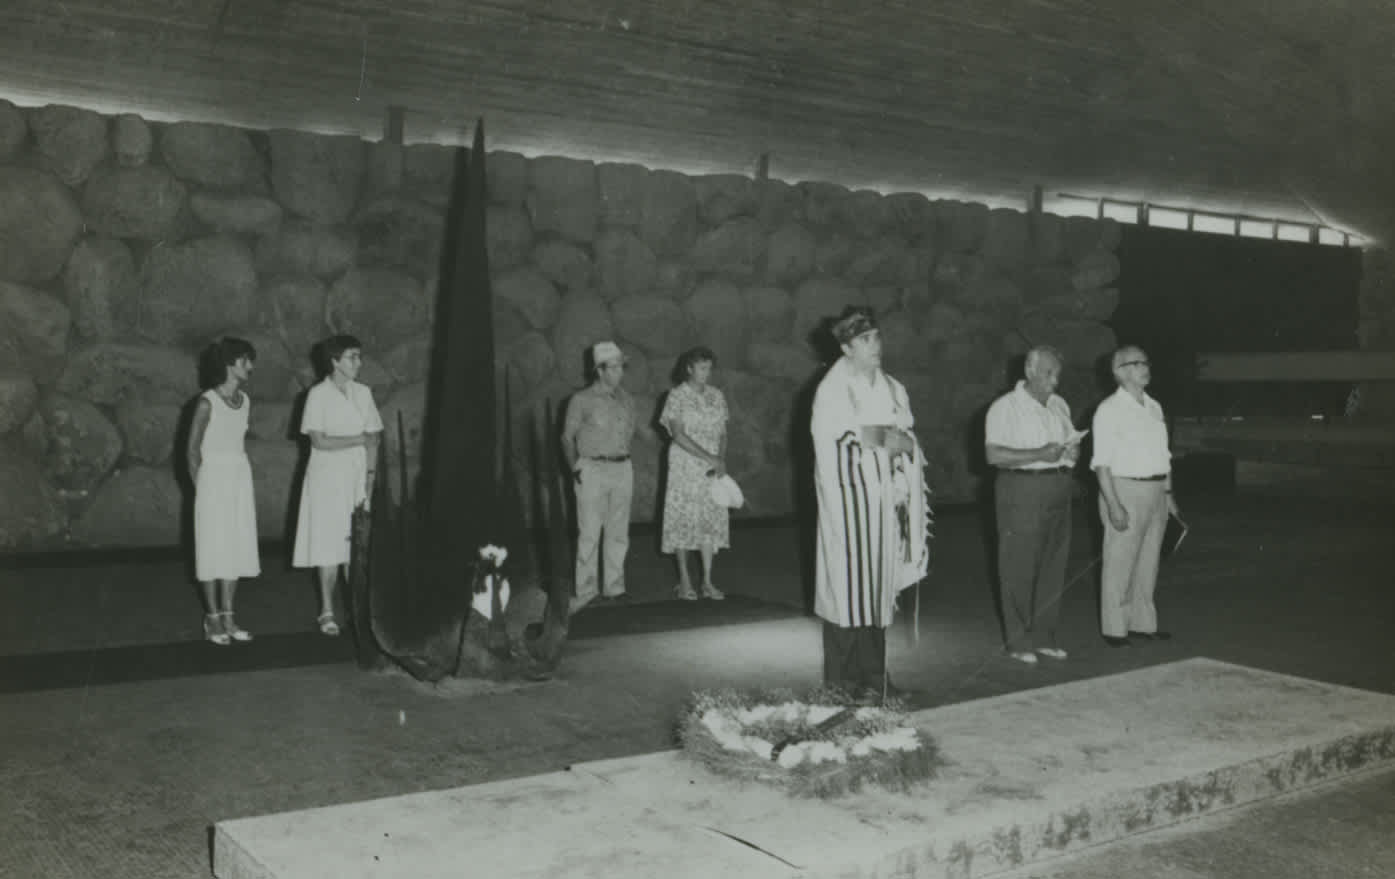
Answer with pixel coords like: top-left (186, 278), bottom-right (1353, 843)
top-left (562, 342), bottom-right (635, 613)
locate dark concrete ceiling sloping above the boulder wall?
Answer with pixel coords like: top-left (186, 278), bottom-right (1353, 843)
top-left (0, 0), bottom-right (1395, 241)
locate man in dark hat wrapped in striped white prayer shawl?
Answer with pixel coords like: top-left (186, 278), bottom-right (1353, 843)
top-left (810, 308), bottom-right (929, 700)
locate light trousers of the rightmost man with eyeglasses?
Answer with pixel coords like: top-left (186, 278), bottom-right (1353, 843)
top-left (1099, 477), bottom-right (1168, 638)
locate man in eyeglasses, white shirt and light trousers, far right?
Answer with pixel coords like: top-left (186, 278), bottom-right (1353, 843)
top-left (1089, 346), bottom-right (1180, 647)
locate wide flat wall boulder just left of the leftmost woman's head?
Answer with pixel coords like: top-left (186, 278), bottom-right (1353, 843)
top-left (57, 342), bottom-right (198, 406)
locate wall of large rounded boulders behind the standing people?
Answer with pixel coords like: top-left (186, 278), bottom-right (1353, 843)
top-left (0, 102), bottom-right (1119, 548)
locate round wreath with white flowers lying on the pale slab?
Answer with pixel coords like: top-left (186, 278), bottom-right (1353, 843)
top-left (678, 689), bottom-right (943, 798)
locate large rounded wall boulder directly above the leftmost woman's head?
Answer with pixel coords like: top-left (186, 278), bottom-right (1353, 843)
top-left (137, 234), bottom-right (257, 345)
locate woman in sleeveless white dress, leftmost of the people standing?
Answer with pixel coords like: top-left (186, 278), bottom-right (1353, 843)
top-left (187, 338), bottom-right (261, 646)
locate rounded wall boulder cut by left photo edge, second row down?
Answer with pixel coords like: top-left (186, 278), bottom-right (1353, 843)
top-left (0, 167), bottom-right (82, 283)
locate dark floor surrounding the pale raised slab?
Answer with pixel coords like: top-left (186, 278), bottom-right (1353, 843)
top-left (0, 498), bottom-right (1395, 879)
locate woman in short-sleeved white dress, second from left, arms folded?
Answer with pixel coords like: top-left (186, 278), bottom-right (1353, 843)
top-left (293, 335), bottom-right (382, 635)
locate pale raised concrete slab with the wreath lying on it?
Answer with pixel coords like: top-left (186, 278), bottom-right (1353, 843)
top-left (213, 659), bottom-right (1395, 879)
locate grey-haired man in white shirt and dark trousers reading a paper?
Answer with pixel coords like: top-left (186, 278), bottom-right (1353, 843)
top-left (983, 346), bottom-right (1085, 666)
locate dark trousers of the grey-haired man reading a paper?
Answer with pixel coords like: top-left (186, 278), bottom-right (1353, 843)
top-left (993, 470), bottom-right (1073, 653)
